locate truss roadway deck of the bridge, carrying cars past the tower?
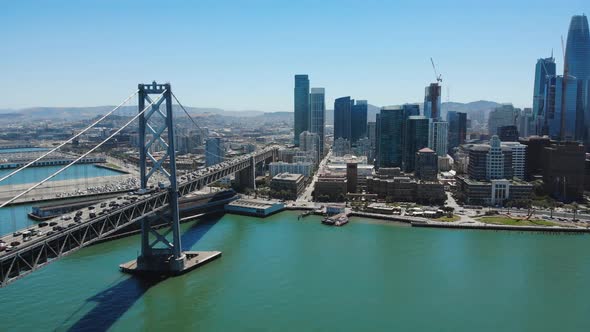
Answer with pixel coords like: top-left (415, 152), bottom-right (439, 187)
top-left (0, 145), bottom-right (278, 287)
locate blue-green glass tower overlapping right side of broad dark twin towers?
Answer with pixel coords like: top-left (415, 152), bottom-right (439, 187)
top-left (402, 115), bottom-right (430, 173)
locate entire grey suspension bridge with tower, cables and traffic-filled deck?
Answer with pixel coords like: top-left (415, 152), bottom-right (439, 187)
top-left (0, 82), bottom-right (279, 286)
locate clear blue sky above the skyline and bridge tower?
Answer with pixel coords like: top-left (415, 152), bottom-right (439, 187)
top-left (0, 0), bottom-right (590, 112)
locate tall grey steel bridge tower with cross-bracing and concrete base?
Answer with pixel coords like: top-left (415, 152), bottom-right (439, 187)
top-left (121, 81), bottom-right (221, 275)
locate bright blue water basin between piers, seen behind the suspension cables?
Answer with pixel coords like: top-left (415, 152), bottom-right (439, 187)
top-left (0, 164), bottom-right (123, 186)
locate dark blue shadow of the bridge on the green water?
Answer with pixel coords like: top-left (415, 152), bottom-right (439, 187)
top-left (63, 216), bottom-right (221, 331)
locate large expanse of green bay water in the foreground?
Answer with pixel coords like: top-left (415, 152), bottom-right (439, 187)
top-left (0, 212), bottom-right (590, 331)
